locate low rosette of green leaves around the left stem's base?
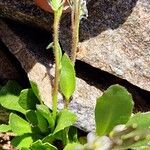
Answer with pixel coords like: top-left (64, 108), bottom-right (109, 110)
top-left (0, 81), bottom-right (76, 150)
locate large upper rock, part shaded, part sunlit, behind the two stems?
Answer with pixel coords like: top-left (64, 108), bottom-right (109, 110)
top-left (0, 0), bottom-right (150, 91)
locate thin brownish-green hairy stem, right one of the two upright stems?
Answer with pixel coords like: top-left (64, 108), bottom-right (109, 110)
top-left (71, 0), bottom-right (81, 64)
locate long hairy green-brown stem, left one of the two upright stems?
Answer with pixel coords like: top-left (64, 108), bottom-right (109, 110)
top-left (52, 8), bottom-right (63, 120)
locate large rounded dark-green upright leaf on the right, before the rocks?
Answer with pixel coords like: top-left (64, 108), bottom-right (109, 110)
top-left (95, 85), bottom-right (134, 136)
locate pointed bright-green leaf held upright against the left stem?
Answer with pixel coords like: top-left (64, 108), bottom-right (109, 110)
top-left (60, 54), bottom-right (76, 100)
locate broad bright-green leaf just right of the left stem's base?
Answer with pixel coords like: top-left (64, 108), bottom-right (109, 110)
top-left (53, 109), bottom-right (77, 134)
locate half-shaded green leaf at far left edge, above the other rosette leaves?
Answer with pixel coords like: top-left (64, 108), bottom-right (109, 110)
top-left (0, 81), bottom-right (25, 114)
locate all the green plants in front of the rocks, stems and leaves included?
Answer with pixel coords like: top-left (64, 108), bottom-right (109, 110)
top-left (0, 0), bottom-right (150, 150)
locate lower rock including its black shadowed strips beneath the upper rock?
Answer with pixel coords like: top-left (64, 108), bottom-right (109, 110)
top-left (0, 20), bottom-right (150, 131)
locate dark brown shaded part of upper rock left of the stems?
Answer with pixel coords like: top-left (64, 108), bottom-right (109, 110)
top-left (0, 0), bottom-right (53, 30)
